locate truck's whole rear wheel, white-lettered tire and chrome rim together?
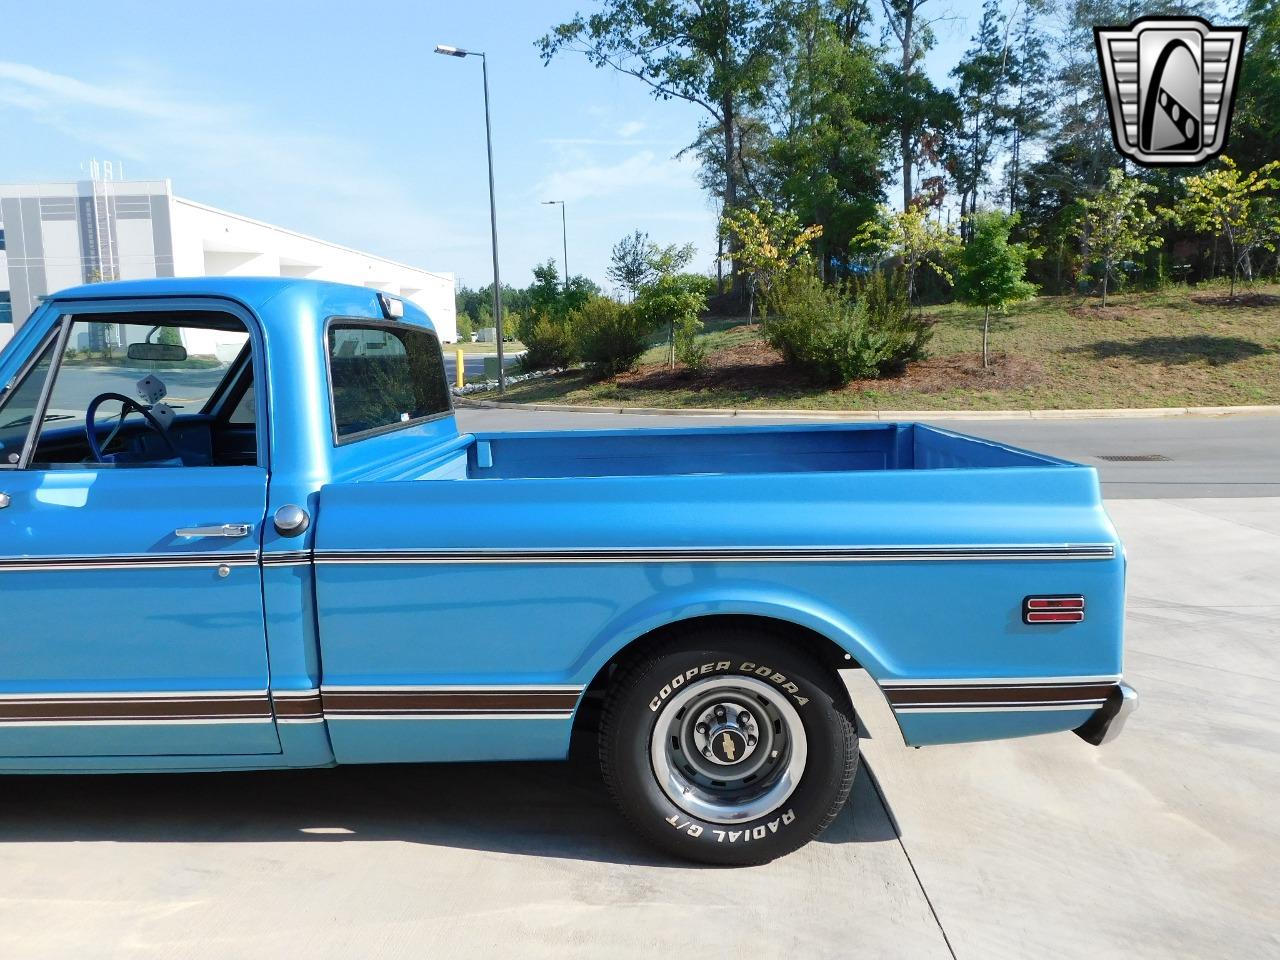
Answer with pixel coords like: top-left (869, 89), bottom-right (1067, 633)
top-left (600, 627), bottom-right (858, 864)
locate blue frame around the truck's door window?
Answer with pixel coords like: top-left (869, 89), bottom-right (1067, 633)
top-left (0, 297), bottom-right (271, 471)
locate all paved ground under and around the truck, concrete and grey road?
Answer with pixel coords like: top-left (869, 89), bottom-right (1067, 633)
top-left (0, 411), bottom-right (1280, 960)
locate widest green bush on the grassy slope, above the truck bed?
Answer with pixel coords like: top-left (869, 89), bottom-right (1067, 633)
top-left (762, 271), bottom-right (931, 385)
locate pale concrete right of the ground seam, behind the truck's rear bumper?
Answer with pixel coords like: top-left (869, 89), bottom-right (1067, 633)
top-left (851, 499), bottom-right (1280, 957)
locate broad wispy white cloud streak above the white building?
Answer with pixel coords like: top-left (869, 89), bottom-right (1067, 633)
top-left (0, 61), bottom-right (488, 269)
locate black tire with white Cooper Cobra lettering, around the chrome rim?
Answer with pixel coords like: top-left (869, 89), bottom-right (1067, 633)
top-left (599, 626), bottom-right (859, 865)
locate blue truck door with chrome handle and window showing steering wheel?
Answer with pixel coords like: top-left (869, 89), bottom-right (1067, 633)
top-left (0, 301), bottom-right (279, 767)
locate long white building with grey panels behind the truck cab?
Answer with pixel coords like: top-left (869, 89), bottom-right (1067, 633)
top-left (0, 180), bottom-right (457, 347)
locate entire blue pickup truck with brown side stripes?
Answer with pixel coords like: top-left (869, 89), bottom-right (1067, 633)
top-left (0, 278), bottom-right (1137, 864)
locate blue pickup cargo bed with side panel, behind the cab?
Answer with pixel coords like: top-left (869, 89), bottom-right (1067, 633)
top-left (314, 424), bottom-right (1124, 759)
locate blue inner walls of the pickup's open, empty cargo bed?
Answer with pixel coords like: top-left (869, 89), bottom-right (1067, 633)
top-left (466, 424), bottom-right (1070, 480)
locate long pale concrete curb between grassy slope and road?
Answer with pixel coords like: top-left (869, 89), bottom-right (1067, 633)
top-left (453, 397), bottom-right (1280, 421)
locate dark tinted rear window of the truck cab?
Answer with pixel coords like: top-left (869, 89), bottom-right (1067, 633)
top-left (326, 320), bottom-right (453, 444)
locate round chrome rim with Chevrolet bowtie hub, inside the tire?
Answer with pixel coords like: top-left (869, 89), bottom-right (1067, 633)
top-left (649, 677), bottom-right (809, 823)
